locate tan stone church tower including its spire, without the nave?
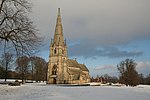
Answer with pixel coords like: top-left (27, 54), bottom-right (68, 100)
top-left (47, 8), bottom-right (68, 84)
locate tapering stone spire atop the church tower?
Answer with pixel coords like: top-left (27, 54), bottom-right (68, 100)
top-left (54, 8), bottom-right (64, 46)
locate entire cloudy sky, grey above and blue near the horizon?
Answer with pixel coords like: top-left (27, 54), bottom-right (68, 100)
top-left (31, 0), bottom-right (150, 76)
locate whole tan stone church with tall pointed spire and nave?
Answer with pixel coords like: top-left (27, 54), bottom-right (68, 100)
top-left (47, 8), bottom-right (90, 84)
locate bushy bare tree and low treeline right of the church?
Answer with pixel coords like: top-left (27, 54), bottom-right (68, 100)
top-left (91, 59), bottom-right (150, 86)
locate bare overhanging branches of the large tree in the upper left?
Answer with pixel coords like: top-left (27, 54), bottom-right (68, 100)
top-left (0, 0), bottom-right (41, 54)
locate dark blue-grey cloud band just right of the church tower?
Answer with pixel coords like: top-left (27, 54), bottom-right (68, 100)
top-left (68, 40), bottom-right (143, 58)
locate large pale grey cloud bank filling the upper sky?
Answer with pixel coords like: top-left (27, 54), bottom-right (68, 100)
top-left (32, 0), bottom-right (150, 46)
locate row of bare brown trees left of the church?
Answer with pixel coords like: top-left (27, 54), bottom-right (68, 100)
top-left (0, 54), bottom-right (47, 82)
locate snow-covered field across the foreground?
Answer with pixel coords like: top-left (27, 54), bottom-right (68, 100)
top-left (0, 83), bottom-right (150, 100)
